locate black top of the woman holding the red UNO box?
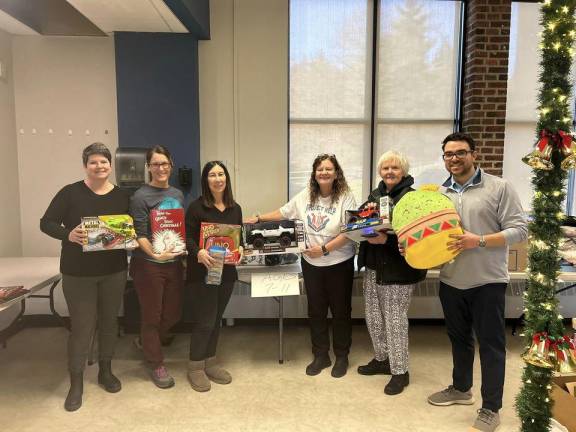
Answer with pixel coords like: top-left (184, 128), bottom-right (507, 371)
top-left (186, 197), bottom-right (242, 282)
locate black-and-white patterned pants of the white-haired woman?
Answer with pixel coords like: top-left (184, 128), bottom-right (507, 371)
top-left (364, 269), bottom-right (416, 375)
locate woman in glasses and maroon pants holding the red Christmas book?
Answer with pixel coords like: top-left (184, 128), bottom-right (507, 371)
top-left (130, 145), bottom-right (184, 389)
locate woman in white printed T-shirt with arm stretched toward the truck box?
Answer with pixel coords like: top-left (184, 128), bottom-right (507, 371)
top-left (246, 154), bottom-right (356, 378)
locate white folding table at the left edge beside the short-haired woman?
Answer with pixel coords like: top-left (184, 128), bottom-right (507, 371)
top-left (0, 257), bottom-right (62, 347)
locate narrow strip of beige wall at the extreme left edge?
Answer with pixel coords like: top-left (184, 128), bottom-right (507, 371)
top-left (0, 30), bottom-right (22, 256)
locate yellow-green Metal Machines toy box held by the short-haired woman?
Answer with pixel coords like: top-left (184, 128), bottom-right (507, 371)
top-left (82, 215), bottom-right (138, 252)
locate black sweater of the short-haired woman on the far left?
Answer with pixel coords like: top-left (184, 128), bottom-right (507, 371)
top-left (40, 180), bottom-right (130, 276)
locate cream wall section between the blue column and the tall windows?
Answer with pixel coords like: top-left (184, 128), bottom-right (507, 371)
top-left (199, 0), bottom-right (288, 215)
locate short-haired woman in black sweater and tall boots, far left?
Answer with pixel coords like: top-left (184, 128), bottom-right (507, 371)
top-left (40, 143), bottom-right (129, 411)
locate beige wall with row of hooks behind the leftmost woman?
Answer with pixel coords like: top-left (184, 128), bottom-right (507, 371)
top-left (13, 36), bottom-right (118, 256)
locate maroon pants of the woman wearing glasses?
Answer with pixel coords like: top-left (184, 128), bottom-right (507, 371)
top-left (130, 258), bottom-right (184, 368)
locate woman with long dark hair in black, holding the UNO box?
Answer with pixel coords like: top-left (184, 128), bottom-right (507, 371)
top-left (186, 161), bottom-right (242, 392)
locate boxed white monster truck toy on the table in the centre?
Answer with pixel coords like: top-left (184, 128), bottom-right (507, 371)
top-left (242, 219), bottom-right (306, 256)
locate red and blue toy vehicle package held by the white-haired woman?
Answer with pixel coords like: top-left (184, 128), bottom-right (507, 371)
top-left (340, 201), bottom-right (391, 242)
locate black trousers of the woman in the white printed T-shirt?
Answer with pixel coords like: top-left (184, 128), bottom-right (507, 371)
top-left (302, 257), bottom-right (354, 357)
